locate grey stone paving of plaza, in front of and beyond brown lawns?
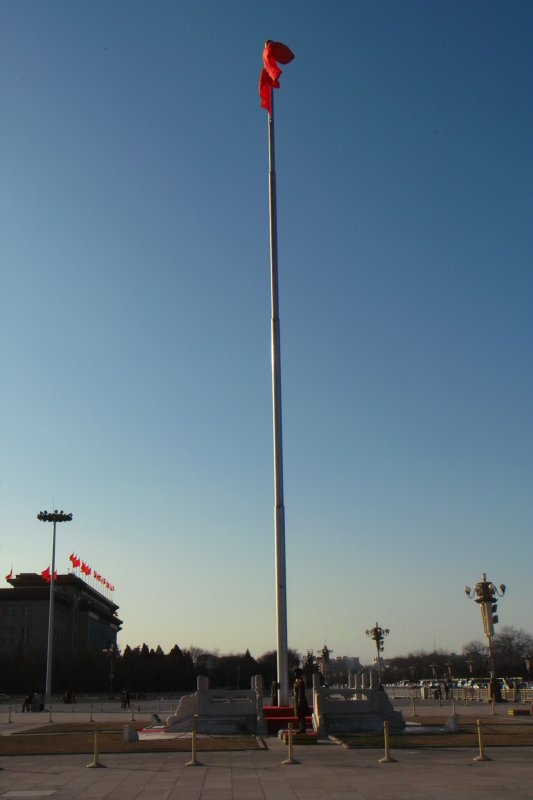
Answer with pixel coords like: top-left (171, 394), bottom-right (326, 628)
top-left (0, 704), bottom-right (533, 800)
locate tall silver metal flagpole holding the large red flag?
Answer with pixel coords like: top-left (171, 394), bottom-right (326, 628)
top-left (268, 92), bottom-right (289, 706)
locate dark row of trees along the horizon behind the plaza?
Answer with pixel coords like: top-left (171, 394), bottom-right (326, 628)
top-left (5, 627), bottom-right (533, 694)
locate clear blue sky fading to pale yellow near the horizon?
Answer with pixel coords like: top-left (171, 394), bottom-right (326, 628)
top-left (0, 0), bottom-right (533, 661)
